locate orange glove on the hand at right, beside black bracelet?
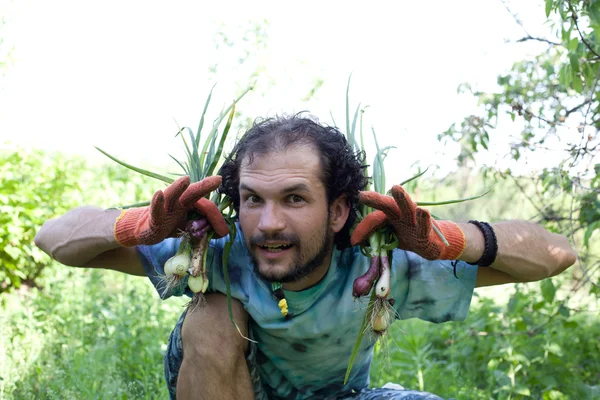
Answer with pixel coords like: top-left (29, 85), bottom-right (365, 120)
top-left (350, 185), bottom-right (466, 260)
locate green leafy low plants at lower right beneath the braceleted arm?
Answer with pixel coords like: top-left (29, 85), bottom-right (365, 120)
top-left (371, 280), bottom-right (600, 399)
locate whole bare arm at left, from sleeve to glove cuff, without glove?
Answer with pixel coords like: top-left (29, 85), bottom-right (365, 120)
top-left (34, 206), bottom-right (145, 276)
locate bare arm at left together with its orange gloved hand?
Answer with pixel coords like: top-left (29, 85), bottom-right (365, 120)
top-left (35, 175), bottom-right (228, 276)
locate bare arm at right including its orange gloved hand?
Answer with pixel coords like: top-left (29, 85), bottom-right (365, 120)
top-left (351, 185), bottom-right (577, 286)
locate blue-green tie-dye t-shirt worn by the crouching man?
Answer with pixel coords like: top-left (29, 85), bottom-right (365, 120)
top-left (138, 227), bottom-right (477, 399)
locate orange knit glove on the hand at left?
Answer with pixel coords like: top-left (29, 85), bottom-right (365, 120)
top-left (115, 176), bottom-right (228, 247)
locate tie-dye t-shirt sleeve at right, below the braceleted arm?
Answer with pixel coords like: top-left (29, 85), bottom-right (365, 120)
top-left (391, 250), bottom-right (478, 323)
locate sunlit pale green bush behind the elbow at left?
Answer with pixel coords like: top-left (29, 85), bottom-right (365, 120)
top-left (0, 148), bottom-right (157, 292)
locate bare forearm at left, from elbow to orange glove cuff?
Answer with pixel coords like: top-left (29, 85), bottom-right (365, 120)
top-left (34, 206), bottom-right (121, 266)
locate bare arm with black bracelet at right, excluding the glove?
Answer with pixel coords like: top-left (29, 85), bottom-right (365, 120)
top-left (459, 221), bottom-right (577, 287)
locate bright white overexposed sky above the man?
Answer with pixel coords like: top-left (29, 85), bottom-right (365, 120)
top-left (0, 0), bottom-right (544, 180)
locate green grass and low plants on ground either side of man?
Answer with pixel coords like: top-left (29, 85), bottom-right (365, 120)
top-left (0, 265), bottom-right (600, 400)
